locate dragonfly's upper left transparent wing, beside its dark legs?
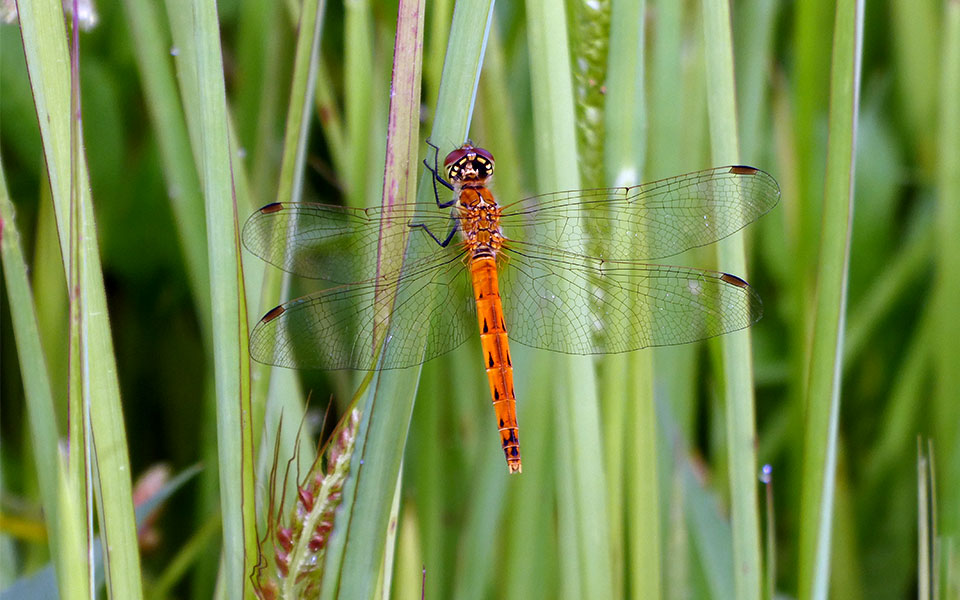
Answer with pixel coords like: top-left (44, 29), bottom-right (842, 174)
top-left (242, 202), bottom-right (459, 283)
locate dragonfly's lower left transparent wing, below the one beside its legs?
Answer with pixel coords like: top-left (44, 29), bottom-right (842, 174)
top-left (250, 253), bottom-right (477, 369)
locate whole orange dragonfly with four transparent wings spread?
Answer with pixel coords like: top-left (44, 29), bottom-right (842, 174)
top-left (242, 142), bottom-right (780, 473)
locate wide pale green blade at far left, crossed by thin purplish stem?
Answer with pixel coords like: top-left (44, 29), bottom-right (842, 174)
top-left (20, 0), bottom-right (142, 599)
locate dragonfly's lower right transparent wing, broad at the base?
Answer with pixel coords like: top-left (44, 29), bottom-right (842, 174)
top-left (500, 242), bottom-right (762, 354)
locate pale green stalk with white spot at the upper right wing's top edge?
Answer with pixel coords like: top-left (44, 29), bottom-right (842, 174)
top-left (600, 0), bottom-right (648, 598)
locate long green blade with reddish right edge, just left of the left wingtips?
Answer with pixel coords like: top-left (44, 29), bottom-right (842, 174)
top-left (182, 2), bottom-right (257, 598)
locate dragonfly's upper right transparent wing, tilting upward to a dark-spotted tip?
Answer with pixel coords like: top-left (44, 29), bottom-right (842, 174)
top-left (501, 166), bottom-right (780, 260)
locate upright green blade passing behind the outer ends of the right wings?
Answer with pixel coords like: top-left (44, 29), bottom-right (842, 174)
top-left (703, 0), bottom-right (762, 599)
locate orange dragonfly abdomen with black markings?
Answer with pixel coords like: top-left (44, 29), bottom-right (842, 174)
top-left (470, 256), bottom-right (521, 473)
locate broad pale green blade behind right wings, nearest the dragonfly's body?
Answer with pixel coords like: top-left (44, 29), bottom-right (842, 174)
top-left (526, 0), bottom-right (613, 598)
